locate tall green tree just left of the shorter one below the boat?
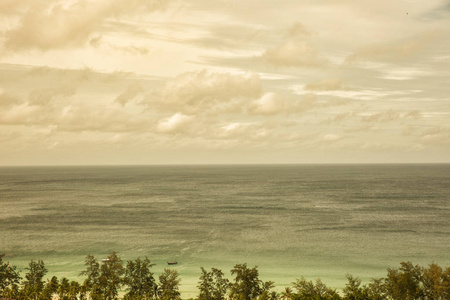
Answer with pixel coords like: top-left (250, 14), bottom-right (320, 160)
top-left (124, 257), bottom-right (156, 300)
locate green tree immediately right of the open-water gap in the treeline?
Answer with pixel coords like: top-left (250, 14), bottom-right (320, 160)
top-left (197, 268), bottom-right (230, 300)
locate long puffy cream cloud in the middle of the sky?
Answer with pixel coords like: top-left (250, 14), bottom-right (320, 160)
top-left (157, 70), bottom-right (324, 118)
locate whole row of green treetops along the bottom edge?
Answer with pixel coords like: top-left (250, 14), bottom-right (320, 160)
top-left (0, 252), bottom-right (450, 300)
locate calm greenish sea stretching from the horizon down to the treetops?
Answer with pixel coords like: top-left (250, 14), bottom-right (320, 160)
top-left (0, 164), bottom-right (450, 297)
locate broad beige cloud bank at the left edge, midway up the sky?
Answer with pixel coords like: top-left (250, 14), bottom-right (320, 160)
top-left (0, 65), bottom-right (155, 135)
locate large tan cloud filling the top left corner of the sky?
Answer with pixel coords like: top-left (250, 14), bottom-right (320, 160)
top-left (5, 0), bottom-right (167, 51)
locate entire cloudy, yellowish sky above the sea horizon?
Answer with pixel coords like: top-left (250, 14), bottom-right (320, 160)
top-left (0, 0), bottom-right (450, 166)
